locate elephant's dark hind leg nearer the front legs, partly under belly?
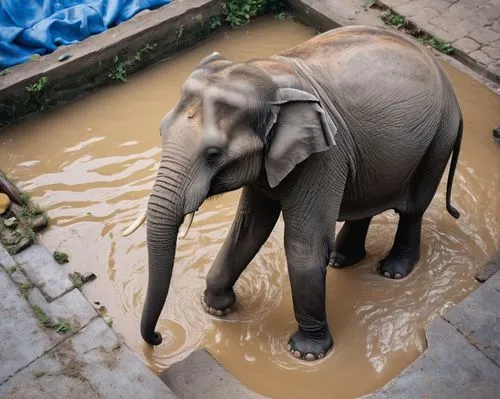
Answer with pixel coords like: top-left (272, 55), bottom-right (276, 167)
top-left (331, 217), bottom-right (372, 268)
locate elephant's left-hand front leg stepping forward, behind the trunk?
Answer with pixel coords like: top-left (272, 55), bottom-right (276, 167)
top-left (202, 186), bottom-right (281, 316)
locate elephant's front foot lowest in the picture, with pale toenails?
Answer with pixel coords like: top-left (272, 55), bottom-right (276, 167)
top-left (288, 328), bottom-right (333, 361)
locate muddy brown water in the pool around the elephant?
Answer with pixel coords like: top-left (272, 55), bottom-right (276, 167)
top-left (0, 19), bottom-right (500, 398)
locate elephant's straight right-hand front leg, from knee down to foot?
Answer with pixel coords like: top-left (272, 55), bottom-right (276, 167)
top-left (285, 232), bottom-right (333, 361)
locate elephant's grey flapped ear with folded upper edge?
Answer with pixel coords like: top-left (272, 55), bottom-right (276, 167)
top-left (265, 88), bottom-right (337, 188)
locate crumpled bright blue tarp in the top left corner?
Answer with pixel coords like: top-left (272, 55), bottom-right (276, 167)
top-left (0, 0), bottom-right (172, 69)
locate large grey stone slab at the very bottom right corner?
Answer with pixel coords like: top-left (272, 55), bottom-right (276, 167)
top-left (362, 318), bottom-right (500, 399)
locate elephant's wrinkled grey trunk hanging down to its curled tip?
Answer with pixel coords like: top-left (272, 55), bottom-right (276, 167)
top-left (141, 166), bottom-right (184, 345)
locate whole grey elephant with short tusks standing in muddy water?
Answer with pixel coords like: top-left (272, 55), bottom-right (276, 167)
top-left (124, 25), bottom-right (463, 361)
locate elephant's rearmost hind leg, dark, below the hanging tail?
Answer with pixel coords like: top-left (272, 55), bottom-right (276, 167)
top-left (379, 213), bottom-right (422, 279)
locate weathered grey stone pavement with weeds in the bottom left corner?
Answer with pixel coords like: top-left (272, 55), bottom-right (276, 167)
top-left (0, 245), bottom-right (175, 399)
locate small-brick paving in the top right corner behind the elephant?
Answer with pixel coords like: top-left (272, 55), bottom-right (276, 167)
top-left (380, 0), bottom-right (500, 83)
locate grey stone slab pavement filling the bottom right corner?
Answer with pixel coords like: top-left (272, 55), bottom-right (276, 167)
top-left (363, 268), bottom-right (500, 399)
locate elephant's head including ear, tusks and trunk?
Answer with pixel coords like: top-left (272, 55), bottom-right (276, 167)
top-left (124, 53), bottom-right (335, 345)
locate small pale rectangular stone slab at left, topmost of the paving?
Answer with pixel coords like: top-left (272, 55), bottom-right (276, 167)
top-left (14, 245), bottom-right (73, 299)
